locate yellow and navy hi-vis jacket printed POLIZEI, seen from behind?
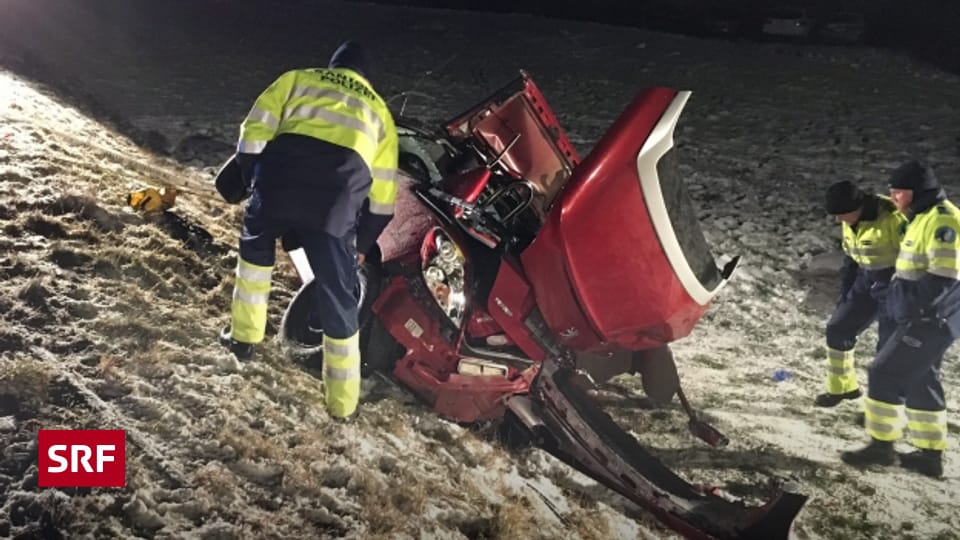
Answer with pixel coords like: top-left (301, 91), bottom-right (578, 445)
top-left (237, 67), bottom-right (398, 252)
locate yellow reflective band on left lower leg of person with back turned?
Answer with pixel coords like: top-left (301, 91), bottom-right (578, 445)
top-left (230, 259), bottom-right (273, 343)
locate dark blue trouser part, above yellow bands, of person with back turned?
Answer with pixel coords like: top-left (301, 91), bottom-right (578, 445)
top-left (240, 194), bottom-right (359, 339)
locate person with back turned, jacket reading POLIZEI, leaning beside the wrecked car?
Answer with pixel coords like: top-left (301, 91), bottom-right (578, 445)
top-left (220, 42), bottom-right (398, 418)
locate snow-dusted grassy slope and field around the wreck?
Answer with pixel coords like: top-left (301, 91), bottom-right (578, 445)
top-left (0, 0), bottom-right (960, 539)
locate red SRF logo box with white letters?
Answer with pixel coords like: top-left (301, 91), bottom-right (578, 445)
top-left (37, 429), bottom-right (127, 487)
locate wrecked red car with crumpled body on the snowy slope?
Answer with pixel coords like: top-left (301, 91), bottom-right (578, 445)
top-left (281, 72), bottom-right (806, 540)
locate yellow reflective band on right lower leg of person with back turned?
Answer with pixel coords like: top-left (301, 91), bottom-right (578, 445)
top-left (323, 332), bottom-right (360, 418)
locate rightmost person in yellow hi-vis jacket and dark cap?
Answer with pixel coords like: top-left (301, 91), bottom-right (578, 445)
top-left (841, 161), bottom-right (960, 477)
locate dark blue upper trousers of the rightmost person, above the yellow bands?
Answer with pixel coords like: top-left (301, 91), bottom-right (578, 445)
top-left (867, 321), bottom-right (954, 411)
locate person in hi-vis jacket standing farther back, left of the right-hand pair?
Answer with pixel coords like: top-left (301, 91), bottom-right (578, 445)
top-left (814, 180), bottom-right (907, 407)
